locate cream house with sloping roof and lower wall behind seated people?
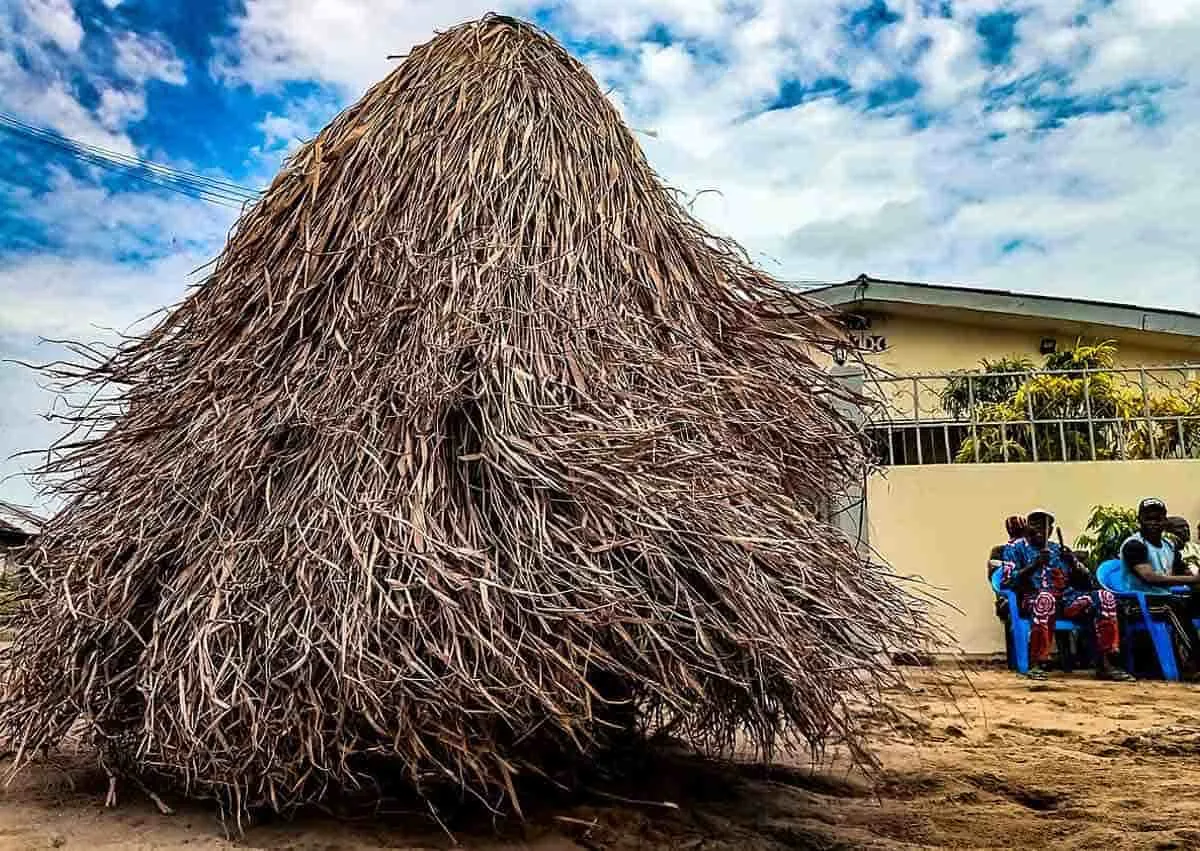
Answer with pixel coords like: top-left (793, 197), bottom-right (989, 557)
top-left (806, 276), bottom-right (1200, 654)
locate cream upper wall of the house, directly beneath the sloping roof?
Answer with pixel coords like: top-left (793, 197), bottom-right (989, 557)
top-left (856, 316), bottom-right (1200, 374)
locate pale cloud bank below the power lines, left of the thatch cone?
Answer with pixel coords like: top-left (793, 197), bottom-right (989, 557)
top-left (0, 175), bottom-right (233, 507)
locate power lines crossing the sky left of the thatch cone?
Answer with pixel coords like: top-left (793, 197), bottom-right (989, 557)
top-left (0, 113), bottom-right (260, 208)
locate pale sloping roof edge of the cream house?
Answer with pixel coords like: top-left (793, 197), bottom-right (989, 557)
top-left (804, 275), bottom-right (1200, 337)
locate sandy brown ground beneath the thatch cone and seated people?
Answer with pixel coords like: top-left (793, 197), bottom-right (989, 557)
top-left (0, 671), bottom-right (1200, 851)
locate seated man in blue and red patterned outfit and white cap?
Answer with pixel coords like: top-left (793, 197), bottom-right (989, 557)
top-left (1004, 509), bottom-right (1133, 682)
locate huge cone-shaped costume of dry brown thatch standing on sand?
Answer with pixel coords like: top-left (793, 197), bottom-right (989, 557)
top-left (0, 18), bottom-right (925, 809)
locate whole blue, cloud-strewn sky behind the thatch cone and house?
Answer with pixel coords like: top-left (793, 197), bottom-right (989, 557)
top-left (0, 0), bottom-right (1200, 502)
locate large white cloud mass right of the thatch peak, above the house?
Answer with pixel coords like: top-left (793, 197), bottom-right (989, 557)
top-left (554, 2), bottom-right (1200, 308)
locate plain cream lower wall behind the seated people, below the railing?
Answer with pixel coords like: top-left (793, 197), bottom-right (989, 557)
top-left (868, 461), bottom-right (1200, 653)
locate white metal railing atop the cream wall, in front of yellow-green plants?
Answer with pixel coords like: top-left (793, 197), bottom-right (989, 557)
top-left (865, 364), bottom-right (1200, 466)
